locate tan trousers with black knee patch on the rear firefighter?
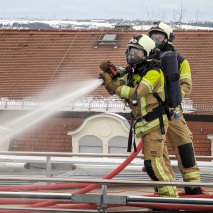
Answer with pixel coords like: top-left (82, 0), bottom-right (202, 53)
top-left (164, 113), bottom-right (200, 185)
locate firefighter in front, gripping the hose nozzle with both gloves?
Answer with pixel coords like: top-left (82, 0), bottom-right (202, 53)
top-left (100, 34), bottom-right (178, 197)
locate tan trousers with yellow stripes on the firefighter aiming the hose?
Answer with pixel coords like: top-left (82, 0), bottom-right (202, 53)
top-left (142, 119), bottom-right (178, 197)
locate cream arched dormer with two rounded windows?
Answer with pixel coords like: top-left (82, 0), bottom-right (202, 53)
top-left (68, 113), bottom-right (139, 154)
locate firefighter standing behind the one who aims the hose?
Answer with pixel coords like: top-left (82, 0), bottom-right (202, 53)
top-left (148, 22), bottom-right (203, 195)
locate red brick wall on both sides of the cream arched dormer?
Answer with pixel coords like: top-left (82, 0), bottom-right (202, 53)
top-left (4, 113), bottom-right (213, 156)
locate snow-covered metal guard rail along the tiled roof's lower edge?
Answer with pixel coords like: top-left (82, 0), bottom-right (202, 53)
top-left (0, 96), bottom-right (210, 113)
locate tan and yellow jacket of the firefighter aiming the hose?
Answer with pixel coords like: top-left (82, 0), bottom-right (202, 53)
top-left (115, 68), bottom-right (166, 136)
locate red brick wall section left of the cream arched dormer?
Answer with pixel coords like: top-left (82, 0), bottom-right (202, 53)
top-left (10, 118), bottom-right (83, 152)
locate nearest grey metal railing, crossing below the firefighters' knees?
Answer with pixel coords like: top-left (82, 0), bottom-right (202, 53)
top-left (0, 176), bottom-right (213, 213)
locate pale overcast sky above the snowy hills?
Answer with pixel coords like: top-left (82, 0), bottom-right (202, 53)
top-left (0, 0), bottom-right (213, 22)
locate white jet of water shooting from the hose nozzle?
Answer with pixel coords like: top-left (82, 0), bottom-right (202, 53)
top-left (0, 79), bottom-right (103, 145)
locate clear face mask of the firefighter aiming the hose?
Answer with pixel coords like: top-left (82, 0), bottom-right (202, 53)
top-left (127, 47), bottom-right (145, 64)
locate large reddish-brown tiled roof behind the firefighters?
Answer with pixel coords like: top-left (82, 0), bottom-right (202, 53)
top-left (0, 29), bottom-right (213, 112)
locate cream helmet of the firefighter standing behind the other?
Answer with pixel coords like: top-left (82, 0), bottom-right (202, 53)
top-left (148, 22), bottom-right (175, 44)
